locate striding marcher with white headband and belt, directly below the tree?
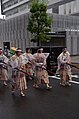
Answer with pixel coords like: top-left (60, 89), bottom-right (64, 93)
top-left (33, 48), bottom-right (52, 89)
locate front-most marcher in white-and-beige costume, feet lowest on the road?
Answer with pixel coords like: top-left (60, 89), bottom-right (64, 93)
top-left (10, 49), bottom-right (27, 96)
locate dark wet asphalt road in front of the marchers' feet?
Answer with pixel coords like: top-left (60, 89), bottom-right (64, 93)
top-left (0, 73), bottom-right (79, 119)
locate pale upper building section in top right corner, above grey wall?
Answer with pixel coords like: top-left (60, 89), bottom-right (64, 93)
top-left (48, 0), bottom-right (79, 16)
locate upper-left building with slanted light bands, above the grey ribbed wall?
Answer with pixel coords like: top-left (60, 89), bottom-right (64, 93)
top-left (1, 0), bottom-right (30, 18)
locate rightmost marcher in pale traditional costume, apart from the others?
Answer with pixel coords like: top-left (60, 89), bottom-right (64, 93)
top-left (57, 47), bottom-right (72, 86)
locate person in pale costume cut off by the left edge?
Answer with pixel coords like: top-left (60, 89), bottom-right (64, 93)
top-left (0, 48), bottom-right (9, 86)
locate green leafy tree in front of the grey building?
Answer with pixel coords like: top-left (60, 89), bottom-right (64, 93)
top-left (28, 0), bottom-right (51, 46)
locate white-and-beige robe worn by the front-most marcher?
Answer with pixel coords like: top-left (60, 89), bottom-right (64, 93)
top-left (10, 55), bottom-right (27, 91)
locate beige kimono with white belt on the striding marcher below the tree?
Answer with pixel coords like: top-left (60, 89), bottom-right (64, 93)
top-left (34, 53), bottom-right (49, 85)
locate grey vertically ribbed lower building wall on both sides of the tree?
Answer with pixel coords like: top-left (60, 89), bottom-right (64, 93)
top-left (0, 13), bottom-right (79, 55)
